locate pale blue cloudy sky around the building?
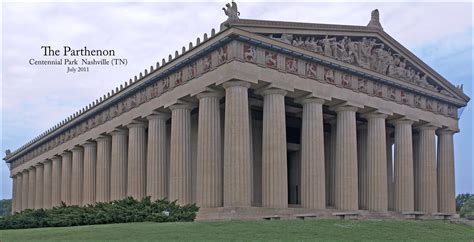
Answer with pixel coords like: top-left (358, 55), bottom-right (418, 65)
top-left (0, 1), bottom-right (474, 199)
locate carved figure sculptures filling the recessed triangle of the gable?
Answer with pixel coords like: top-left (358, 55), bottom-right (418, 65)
top-left (268, 34), bottom-right (453, 97)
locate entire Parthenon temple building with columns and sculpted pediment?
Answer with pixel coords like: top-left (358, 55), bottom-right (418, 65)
top-left (4, 3), bottom-right (469, 219)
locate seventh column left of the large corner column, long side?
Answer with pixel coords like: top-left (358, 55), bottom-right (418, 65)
top-left (82, 141), bottom-right (97, 205)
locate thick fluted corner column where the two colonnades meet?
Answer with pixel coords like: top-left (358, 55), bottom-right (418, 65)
top-left (223, 81), bottom-right (253, 207)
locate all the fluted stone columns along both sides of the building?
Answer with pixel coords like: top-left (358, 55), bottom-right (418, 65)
top-left (13, 81), bottom-right (454, 216)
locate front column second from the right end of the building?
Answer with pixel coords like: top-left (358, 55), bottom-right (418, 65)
top-left (418, 125), bottom-right (438, 213)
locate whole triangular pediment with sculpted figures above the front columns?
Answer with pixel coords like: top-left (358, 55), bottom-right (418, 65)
top-left (229, 19), bottom-right (469, 103)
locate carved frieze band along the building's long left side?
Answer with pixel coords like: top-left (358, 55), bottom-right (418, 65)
top-left (11, 42), bottom-right (232, 168)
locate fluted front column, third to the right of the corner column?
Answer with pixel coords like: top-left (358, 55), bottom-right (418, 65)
top-left (334, 105), bottom-right (359, 210)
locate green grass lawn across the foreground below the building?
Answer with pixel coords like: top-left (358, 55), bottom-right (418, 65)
top-left (0, 220), bottom-right (474, 242)
